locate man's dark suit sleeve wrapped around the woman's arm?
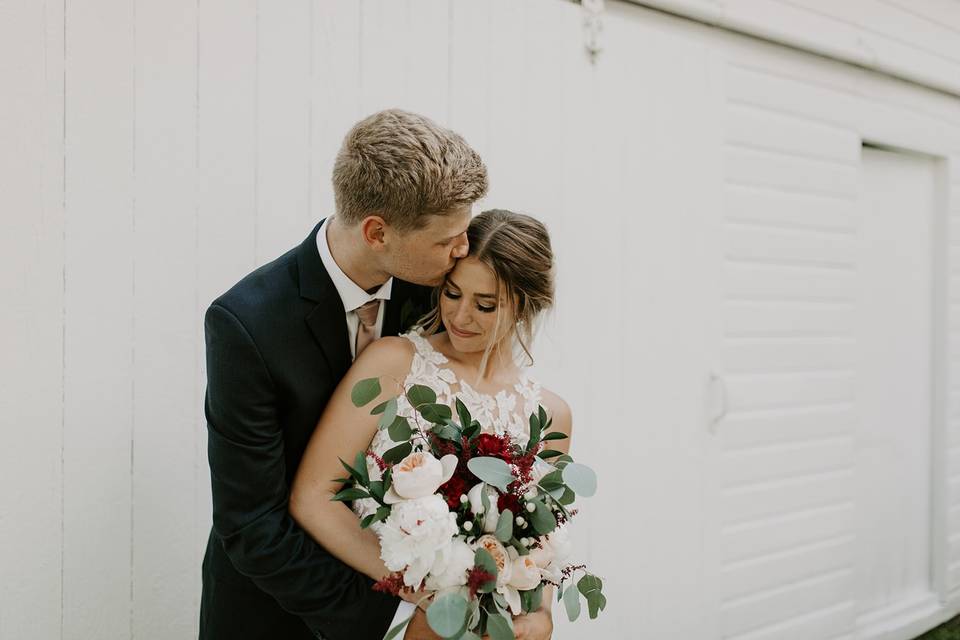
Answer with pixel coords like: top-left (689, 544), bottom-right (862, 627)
top-left (204, 303), bottom-right (399, 640)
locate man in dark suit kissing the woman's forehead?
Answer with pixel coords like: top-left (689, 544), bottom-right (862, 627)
top-left (200, 110), bottom-right (487, 640)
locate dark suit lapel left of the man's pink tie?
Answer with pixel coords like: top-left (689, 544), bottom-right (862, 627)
top-left (297, 220), bottom-right (351, 378)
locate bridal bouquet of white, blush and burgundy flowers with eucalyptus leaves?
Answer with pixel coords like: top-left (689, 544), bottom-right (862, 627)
top-left (333, 378), bottom-right (606, 640)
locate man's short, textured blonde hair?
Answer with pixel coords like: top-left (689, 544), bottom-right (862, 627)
top-left (333, 109), bottom-right (487, 231)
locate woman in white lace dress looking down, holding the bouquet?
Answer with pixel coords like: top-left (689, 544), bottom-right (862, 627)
top-left (290, 210), bottom-right (571, 639)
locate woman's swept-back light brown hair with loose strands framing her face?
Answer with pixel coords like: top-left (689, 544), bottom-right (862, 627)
top-left (420, 209), bottom-right (554, 376)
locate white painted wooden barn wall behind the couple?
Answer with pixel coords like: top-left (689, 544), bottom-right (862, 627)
top-left (0, 0), bottom-right (960, 640)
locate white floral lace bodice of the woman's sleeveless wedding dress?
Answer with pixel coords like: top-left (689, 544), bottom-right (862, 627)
top-left (353, 331), bottom-right (541, 531)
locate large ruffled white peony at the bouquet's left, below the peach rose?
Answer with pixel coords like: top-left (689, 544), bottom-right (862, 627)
top-left (380, 494), bottom-right (458, 587)
